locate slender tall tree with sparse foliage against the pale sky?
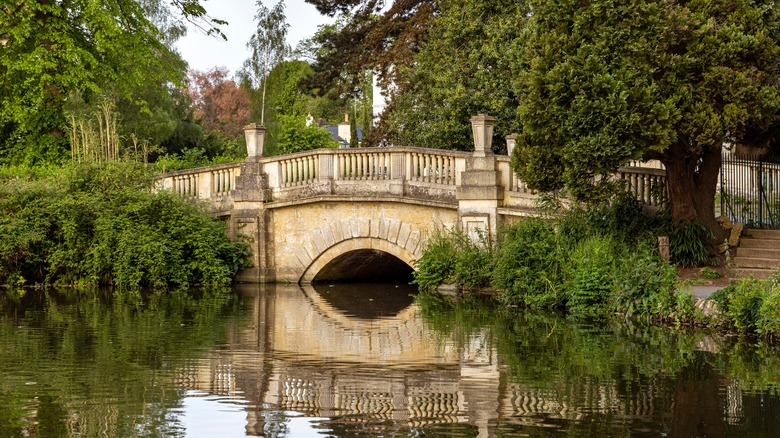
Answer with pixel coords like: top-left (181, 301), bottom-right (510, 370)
top-left (244, 0), bottom-right (290, 124)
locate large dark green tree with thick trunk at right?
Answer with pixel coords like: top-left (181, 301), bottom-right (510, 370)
top-left (514, 0), bottom-right (780, 236)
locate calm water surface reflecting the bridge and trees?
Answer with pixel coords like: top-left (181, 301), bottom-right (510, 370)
top-left (0, 284), bottom-right (780, 438)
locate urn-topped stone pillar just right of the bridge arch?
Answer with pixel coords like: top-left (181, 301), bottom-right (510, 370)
top-left (455, 114), bottom-right (504, 242)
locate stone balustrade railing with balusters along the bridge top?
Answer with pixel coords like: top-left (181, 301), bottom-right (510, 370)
top-left (158, 147), bottom-right (667, 213)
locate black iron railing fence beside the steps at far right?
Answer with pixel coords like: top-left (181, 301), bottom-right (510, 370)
top-left (720, 152), bottom-right (780, 229)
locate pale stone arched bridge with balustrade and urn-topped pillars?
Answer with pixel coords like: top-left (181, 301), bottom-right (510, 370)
top-left (160, 115), bottom-right (664, 283)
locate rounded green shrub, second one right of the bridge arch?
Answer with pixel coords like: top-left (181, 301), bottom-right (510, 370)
top-left (493, 219), bottom-right (563, 308)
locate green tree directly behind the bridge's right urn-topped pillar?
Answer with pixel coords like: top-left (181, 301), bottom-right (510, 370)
top-left (394, 0), bottom-right (528, 150)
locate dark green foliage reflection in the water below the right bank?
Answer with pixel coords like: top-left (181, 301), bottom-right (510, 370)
top-left (418, 295), bottom-right (780, 437)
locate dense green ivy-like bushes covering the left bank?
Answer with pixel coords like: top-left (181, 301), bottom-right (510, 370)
top-left (0, 163), bottom-right (249, 288)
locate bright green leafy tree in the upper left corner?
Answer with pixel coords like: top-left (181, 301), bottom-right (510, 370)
top-left (0, 0), bottom-right (221, 162)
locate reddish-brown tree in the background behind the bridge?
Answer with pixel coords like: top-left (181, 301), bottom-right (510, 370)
top-left (187, 67), bottom-right (250, 139)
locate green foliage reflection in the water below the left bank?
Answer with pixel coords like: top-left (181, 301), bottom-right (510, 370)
top-left (0, 290), bottom-right (235, 437)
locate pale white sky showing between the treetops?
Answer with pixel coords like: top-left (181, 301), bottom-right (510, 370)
top-left (176, 0), bottom-right (335, 74)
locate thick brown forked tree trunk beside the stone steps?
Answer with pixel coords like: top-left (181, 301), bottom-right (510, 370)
top-left (661, 145), bottom-right (725, 242)
